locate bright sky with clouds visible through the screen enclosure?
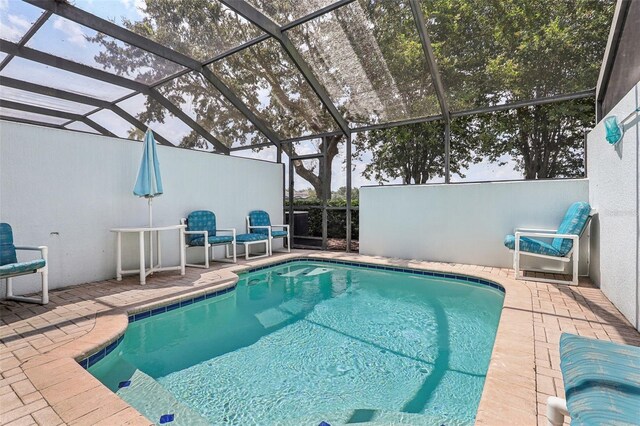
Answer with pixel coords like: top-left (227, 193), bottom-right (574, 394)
top-left (0, 0), bottom-right (522, 190)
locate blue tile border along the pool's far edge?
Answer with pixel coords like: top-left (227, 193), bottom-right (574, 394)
top-left (242, 257), bottom-right (505, 293)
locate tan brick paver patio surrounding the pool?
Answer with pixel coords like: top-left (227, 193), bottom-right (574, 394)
top-left (0, 251), bottom-right (640, 425)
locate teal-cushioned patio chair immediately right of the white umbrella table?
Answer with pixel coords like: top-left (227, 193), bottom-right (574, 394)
top-left (180, 210), bottom-right (236, 268)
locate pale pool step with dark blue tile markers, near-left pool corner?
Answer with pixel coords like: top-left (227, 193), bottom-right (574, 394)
top-left (116, 361), bottom-right (209, 426)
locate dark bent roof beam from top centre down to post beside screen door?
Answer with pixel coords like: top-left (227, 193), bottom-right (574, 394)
top-left (220, 0), bottom-right (351, 135)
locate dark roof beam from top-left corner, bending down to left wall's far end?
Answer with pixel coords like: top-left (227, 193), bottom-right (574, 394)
top-left (25, 0), bottom-right (280, 145)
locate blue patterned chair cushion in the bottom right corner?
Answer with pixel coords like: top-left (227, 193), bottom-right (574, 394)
top-left (560, 333), bottom-right (640, 426)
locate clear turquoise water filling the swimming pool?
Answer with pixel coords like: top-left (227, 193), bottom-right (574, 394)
top-left (89, 261), bottom-right (504, 426)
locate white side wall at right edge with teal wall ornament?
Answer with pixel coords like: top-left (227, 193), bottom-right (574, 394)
top-left (587, 83), bottom-right (640, 329)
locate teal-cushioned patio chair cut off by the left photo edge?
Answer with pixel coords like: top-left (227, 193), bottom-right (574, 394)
top-left (0, 223), bottom-right (49, 305)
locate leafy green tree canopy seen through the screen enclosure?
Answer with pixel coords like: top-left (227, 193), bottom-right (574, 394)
top-left (92, 0), bottom-right (614, 191)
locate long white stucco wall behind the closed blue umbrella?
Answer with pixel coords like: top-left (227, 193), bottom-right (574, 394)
top-left (0, 121), bottom-right (283, 296)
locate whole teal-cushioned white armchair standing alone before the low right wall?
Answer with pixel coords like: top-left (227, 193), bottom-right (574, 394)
top-left (504, 201), bottom-right (595, 285)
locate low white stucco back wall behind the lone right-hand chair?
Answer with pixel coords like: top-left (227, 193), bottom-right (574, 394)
top-left (360, 179), bottom-right (589, 274)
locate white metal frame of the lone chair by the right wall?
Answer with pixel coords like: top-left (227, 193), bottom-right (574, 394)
top-left (510, 209), bottom-right (596, 285)
